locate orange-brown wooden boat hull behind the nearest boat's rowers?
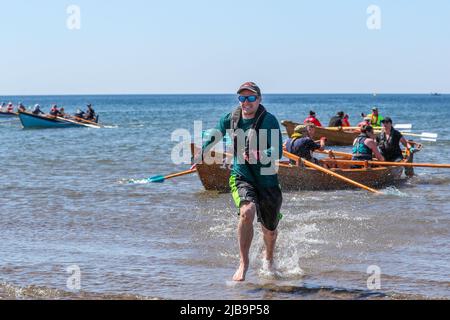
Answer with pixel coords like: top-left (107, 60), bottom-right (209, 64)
top-left (281, 120), bottom-right (359, 146)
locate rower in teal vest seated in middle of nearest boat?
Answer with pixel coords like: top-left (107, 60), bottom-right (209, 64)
top-left (352, 125), bottom-right (385, 161)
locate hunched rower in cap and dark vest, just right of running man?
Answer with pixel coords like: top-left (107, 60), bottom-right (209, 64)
top-left (285, 123), bottom-right (327, 164)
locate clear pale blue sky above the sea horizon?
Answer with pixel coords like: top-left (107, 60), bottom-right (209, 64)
top-left (0, 0), bottom-right (450, 95)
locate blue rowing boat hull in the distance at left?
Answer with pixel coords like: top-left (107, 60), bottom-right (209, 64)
top-left (19, 112), bottom-right (101, 129)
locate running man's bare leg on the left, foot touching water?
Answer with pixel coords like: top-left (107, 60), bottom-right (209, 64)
top-left (233, 202), bottom-right (256, 281)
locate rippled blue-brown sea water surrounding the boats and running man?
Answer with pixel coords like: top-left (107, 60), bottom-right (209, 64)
top-left (0, 94), bottom-right (450, 299)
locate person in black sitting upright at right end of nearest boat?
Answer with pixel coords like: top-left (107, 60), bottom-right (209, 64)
top-left (377, 117), bottom-right (414, 162)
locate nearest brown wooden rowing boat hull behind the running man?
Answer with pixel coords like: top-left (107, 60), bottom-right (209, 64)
top-left (191, 146), bottom-right (412, 192)
